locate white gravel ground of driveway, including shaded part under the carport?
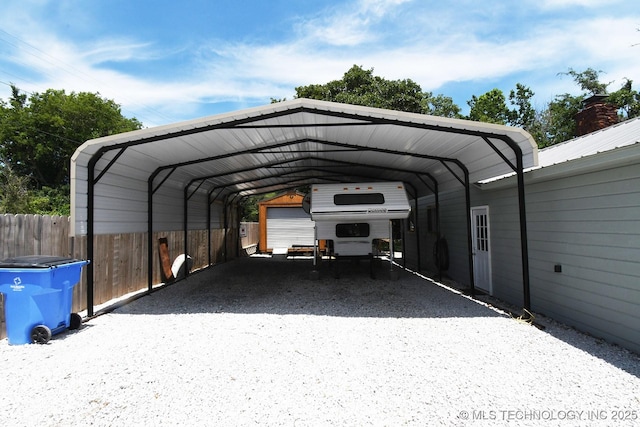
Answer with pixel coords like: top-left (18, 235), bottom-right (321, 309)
top-left (0, 258), bottom-right (640, 426)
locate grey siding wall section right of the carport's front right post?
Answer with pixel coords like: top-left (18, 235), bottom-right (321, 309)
top-left (527, 164), bottom-right (640, 352)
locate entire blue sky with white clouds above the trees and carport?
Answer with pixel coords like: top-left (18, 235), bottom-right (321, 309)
top-left (0, 0), bottom-right (640, 127)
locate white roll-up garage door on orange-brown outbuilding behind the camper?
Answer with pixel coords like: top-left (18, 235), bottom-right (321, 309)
top-left (267, 207), bottom-right (314, 249)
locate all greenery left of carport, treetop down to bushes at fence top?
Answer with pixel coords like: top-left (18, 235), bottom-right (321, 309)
top-left (0, 86), bottom-right (142, 213)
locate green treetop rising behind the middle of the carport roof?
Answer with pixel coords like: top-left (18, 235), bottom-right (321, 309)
top-left (296, 65), bottom-right (460, 117)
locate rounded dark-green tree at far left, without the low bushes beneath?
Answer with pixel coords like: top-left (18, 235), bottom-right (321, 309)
top-left (0, 86), bottom-right (142, 188)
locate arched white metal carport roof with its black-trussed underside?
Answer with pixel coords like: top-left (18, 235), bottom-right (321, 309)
top-left (71, 99), bottom-right (537, 232)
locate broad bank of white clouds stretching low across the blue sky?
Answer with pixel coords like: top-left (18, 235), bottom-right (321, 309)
top-left (0, 0), bottom-right (640, 125)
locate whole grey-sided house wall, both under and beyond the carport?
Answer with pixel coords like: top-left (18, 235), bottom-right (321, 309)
top-left (407, 154), bottom-right (640, 352)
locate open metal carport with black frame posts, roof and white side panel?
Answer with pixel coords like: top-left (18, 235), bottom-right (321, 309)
top-left (71, 99), bottom-right (537, 316)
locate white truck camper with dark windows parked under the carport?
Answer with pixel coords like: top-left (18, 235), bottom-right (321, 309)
top-left (308, 182), bottom-right (411, 257)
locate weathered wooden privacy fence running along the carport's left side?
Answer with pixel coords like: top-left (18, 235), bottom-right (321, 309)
top-left (0, 214), bottom-right (258, 338)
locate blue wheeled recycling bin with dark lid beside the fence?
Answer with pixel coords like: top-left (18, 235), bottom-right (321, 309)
top-left (0, 255), bottom-right (88, 345)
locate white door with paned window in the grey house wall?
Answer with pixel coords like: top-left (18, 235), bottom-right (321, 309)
top-left (471, 206), bottom-right (493, 295)
